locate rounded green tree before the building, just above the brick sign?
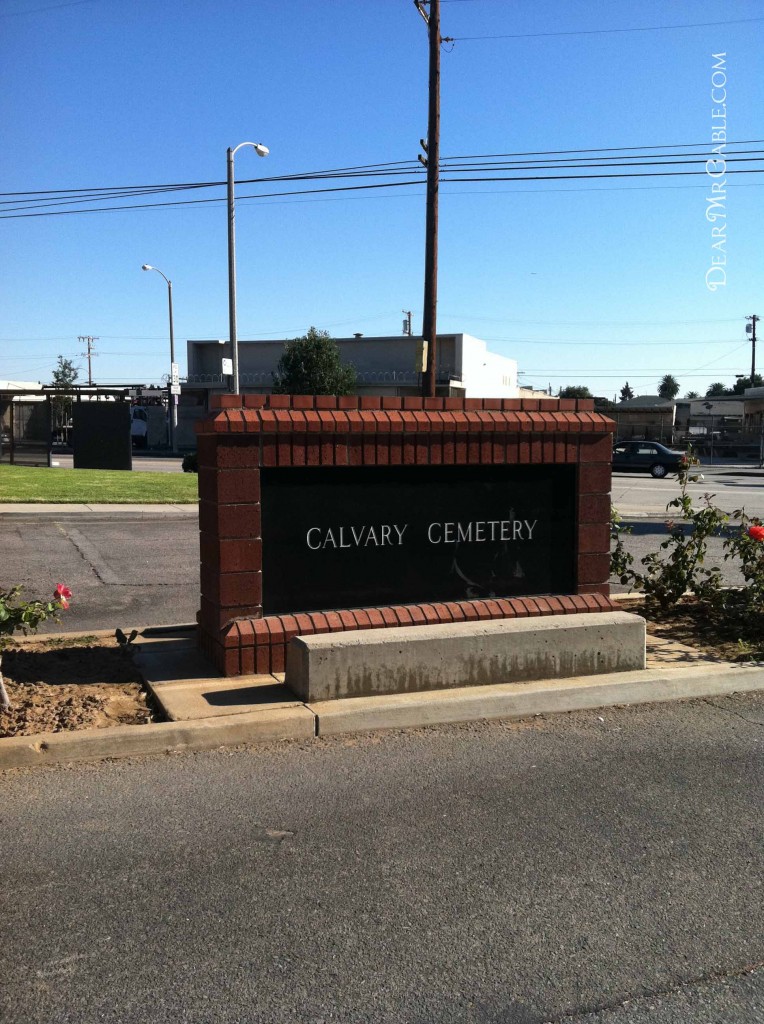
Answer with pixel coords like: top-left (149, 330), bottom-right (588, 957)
top-left (272, 327), bottom-right (355, 395)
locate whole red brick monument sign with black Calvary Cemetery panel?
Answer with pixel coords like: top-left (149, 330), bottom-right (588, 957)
top-left (197, 394), bottom-right (616, 676)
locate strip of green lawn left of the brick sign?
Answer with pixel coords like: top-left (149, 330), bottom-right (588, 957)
top-left (0, 466), bottom-right (199, 505)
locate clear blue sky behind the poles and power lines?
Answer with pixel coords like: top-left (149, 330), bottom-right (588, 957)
top-left (0, 0), bottom-right (764, 397)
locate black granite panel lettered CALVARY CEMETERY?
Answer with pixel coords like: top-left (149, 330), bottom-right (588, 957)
top-left (260, 466), bottom-right (576, 615)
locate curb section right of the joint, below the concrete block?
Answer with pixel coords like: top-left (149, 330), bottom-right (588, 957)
top-left (307, 664), bottom-right (764, 736)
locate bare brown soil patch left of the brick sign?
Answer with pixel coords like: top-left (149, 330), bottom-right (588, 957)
top-left (0, 636), bottom-right (154, 737)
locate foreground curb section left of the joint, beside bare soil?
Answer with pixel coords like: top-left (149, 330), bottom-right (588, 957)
top-left (0, 707), bottom-right (315, 769)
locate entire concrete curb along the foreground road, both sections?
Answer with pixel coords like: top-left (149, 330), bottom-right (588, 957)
top-left (0, 663), bottom-right (764, 770)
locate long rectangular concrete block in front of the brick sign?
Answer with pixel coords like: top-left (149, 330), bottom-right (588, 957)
top-left (287, 611), bottom-right (645, 702)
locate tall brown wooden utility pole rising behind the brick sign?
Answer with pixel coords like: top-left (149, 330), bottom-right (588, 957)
top-left (414, 0), bottom-right (442, 398)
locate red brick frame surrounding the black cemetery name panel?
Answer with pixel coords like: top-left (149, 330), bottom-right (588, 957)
top-left (197, 394), bottom-right (614, 675)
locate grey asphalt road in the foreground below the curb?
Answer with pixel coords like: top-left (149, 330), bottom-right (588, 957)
top-left (0, 694), bottom-right (764, 1024)
